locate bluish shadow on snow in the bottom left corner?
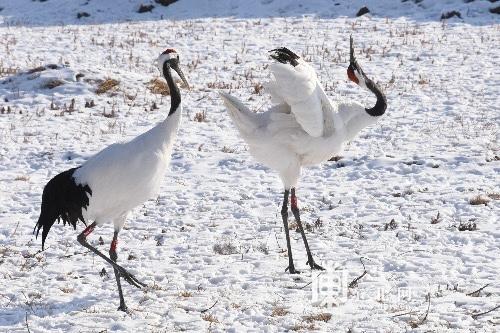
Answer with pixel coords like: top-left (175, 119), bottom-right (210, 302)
top-left (0, 296), bottom-right (100, 324)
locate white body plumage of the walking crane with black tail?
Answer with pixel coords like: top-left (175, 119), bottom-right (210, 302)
top-left (74, 105), bottom-right (182, 230)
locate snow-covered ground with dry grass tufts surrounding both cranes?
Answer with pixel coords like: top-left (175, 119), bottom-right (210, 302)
top-left (0, 0), bottom-right (500, 332)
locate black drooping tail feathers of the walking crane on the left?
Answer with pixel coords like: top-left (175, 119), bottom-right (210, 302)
top-left (33, 168), bottom-right (92, 249)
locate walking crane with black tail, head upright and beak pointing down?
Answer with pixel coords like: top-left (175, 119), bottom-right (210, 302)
top-left (34, 49), bottom-right (188, 311)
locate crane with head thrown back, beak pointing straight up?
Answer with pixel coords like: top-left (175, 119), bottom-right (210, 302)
top-left (221, 37), bottom-right (387, 274)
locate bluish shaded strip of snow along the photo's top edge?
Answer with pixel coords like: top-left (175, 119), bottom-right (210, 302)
top-left (0, 0), bottom-right (500, 27)
